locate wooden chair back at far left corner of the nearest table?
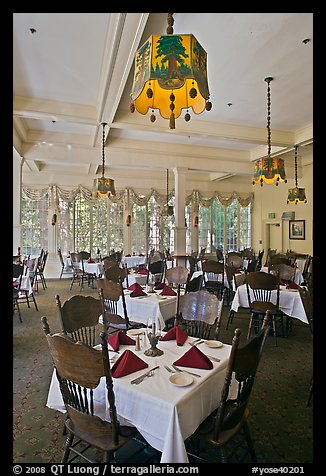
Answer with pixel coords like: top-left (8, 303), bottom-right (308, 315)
top-left (55, 294), bottom-right (102, 346)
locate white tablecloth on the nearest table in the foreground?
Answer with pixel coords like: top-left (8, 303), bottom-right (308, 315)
top-left (46, 332), bottom-right (232, 463)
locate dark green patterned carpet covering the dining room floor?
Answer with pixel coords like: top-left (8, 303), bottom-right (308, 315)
top-left (13, 279), bottom-right (313, 463)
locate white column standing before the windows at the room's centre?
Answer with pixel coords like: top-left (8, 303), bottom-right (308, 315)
top-left (173, 167), bottom-right (188, 255)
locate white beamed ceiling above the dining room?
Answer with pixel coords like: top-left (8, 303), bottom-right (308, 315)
top-left (13, 13), bottom-right (313, 190)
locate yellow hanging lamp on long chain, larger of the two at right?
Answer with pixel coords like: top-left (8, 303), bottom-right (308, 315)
top-left (252, 77), bottom-right (287, 187)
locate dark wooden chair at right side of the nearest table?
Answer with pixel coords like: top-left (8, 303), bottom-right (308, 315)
top-left (186, 312), bottom-right (269, 463)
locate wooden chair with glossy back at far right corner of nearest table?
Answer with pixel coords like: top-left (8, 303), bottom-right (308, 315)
top-left (179, 289), bottom-right (225, 339)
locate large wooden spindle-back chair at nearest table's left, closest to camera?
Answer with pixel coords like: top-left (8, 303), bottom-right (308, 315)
top-left (42, 314), bottom-right (138, 463)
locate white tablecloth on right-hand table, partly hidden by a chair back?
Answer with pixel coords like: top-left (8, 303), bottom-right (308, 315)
top-left (231, 284), bottom-right (309, 324)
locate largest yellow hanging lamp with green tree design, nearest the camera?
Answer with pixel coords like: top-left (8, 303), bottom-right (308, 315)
top-left (130, 13), bottom-right (212, 129)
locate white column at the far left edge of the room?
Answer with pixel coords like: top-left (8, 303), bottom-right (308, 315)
top-left (12, 149), bottom-right (24, 255)
